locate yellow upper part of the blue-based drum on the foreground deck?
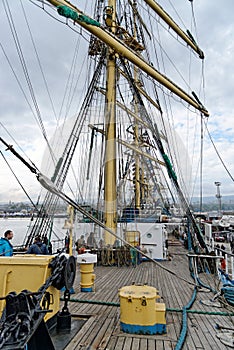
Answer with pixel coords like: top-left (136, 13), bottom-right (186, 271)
top-left (119, 285), bottom-right (166, 326)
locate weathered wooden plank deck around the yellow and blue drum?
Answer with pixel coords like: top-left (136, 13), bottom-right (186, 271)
top-left (61, 239), bottom-right (234, 350)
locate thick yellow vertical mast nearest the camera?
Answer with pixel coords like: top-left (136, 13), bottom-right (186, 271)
top-left (104, 0), bottom-right (117, 246)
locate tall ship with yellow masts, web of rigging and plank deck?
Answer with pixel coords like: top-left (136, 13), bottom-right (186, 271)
top-left (0, 0), bottom-right (234, 350)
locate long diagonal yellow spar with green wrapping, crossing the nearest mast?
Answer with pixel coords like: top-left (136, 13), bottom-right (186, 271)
top-left (45, 0), bottom-right (209, 116)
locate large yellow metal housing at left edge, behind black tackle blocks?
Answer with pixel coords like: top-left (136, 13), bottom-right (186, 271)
top-left (0, 254), bottom-right (60, 321)
